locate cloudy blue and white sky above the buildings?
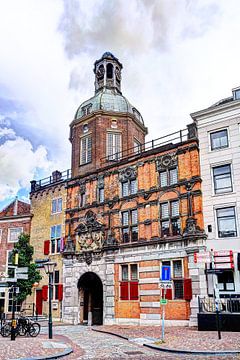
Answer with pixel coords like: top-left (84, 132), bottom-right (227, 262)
top-left (0, 0), bottom-right (240, 209)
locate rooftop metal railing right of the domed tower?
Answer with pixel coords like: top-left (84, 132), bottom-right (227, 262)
top-left (101, 129), bottom-right (191, 165)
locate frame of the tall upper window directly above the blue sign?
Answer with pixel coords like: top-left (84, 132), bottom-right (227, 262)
top-left (159, 199), bottom-right (182, 238)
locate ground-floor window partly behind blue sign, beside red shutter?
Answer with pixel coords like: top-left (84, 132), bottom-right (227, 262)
top-left (162, 260), bottom-right (184, 299)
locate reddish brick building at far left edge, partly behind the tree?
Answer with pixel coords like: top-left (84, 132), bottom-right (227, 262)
top-left (0, 198), bottom-right (32, 313)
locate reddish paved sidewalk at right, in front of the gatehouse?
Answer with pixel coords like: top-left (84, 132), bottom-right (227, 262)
top-left (96, 325), bottom-right (240, 352)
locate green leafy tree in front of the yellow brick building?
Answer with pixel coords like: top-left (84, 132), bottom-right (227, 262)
top-left (13, 234), bottom-right (42, 302)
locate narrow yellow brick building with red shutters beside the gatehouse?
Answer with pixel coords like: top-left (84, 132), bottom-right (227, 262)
top-left (26, 171), bottom-right (71, 319)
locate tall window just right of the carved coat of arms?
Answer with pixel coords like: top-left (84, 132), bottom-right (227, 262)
top-left (122, 210), bottom-right (138, 243)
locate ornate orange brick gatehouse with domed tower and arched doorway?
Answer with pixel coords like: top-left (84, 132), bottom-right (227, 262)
top-left (58, 53), bottom-right (206, 325)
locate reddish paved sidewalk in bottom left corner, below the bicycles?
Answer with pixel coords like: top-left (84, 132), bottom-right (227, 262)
top-left (0, 334), bottom-right (83, 360)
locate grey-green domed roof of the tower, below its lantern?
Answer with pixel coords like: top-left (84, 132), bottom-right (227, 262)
top-left (75, 88), bottom-right (144, 125)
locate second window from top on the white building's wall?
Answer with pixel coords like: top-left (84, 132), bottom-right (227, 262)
top-left (213, 164), bottom-right (233, 194)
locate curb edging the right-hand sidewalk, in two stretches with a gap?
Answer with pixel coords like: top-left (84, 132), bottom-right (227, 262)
top-left (92, 329), bottom-right (240, 360)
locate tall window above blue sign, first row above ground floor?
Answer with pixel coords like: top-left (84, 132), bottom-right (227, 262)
top-left (160, 200), bottom-right (181, 237)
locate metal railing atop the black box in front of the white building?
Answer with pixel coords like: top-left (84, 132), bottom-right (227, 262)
top-left (198, 296), bottom-right (240, 313)
